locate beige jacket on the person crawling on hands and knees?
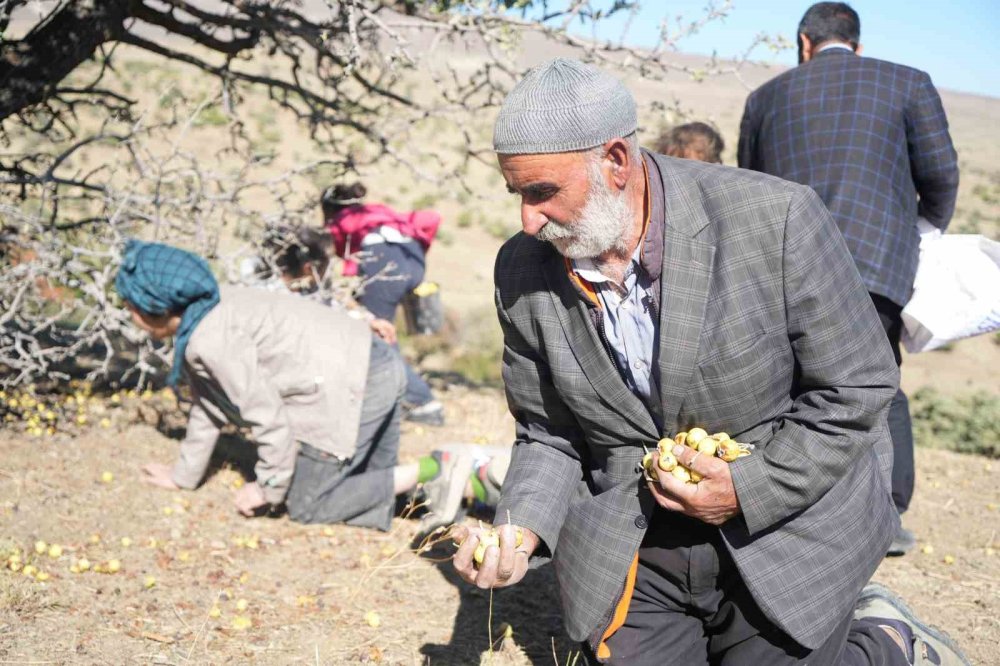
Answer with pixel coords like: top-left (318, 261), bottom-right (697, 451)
top-left (173, 287), bottom-right (371, 504)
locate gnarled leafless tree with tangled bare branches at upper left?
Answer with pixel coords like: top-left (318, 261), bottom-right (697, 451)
top-left (0, 0), bottom-right (776, 385)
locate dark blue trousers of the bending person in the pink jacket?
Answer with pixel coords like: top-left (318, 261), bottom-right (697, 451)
top-left (355, 241), bottom-right (434, 407)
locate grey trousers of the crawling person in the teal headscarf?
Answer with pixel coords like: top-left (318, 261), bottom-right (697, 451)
top-left (287, 338), bottom-right (406, 531)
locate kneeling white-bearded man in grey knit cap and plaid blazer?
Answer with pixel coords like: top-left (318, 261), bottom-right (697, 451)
top-left (454, 59), bottom-right (962, 666)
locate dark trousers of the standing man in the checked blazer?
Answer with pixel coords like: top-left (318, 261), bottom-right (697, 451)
top-left (871, 294), bottom-right (914, 514)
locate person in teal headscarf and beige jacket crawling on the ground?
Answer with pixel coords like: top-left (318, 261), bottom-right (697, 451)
top-left (115, 240), bottom-right (468, 530)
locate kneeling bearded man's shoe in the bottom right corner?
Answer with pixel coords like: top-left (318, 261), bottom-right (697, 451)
top-left (854, 583), bottom-right (972, 666)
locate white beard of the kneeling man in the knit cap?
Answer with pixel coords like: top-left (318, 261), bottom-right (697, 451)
top-left (535, 162), bottom-right (632, 259)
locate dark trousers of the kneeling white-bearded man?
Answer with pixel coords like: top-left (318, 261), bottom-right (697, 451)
top-left (584, 512), bottom-right (908, 666)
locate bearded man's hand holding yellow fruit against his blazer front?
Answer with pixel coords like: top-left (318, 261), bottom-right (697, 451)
top-left (648, 445), bottom-right (740, 525)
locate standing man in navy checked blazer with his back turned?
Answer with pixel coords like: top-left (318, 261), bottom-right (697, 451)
top-left (738, 2), bottom-right (958, 555)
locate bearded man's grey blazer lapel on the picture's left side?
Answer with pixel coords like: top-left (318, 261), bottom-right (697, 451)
top-left (545, 252), bottom-right (660, 441)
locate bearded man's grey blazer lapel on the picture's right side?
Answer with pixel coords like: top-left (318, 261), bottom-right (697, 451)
top-left (656, 158), bottom-right (715, 434)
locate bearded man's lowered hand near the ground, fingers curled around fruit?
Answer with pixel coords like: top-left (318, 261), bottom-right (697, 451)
top-left (452, 525), bottom-right (538, 590)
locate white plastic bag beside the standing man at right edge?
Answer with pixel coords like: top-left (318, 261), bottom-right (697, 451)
top-left (901, 220), bottom-right (1000, 354)
